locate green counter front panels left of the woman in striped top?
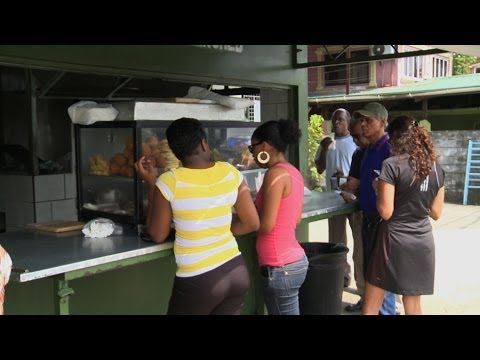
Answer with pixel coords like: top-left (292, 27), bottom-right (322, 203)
top-left (5, 255), bottom-right (175, 315)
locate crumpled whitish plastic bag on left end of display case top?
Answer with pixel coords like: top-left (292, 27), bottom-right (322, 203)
top-left (68, 101), bottom-right (118, 125)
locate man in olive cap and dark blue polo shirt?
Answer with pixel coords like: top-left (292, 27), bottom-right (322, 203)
top-left (353, 102), bottom-right (396, 315)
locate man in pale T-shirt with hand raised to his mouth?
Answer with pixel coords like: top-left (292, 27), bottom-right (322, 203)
top-left (315, 108), bottom-right (357, 287)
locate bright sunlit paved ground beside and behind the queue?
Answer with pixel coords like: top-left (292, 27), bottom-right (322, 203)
top-left (310, 204), bottom-right (480, 315)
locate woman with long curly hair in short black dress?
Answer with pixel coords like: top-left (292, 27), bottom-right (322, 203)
top-left (363, 116), bottom-right (445, 315)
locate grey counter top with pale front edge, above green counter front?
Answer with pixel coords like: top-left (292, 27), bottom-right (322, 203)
top-left (0, 191), bottom-right (356, 282)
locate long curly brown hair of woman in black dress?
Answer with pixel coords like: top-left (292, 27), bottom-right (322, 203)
top-left (387, 115), bottom-right (437, 179)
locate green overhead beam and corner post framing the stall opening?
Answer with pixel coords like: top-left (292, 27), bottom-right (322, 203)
top-left (0, 45), bottom-right (308, 179)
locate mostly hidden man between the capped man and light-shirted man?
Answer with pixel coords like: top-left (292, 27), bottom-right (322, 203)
top-left (341, 116), bottom-right (368, 312)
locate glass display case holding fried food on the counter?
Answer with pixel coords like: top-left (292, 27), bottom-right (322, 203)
top-left (75, 120), bottom-right (264, 224)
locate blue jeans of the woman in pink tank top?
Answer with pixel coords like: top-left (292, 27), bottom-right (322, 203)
top-left (260, 256), bottom-right (308, 315)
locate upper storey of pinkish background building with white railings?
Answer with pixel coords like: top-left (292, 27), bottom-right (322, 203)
top-left (308, 45), bottom-right (453, 97)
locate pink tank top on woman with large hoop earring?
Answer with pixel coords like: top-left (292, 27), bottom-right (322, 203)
top-left (255, 163), bottom-right (305, 266)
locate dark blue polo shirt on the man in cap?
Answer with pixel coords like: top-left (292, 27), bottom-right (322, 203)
top-left (358, 134), bottom-right (390, 215)
